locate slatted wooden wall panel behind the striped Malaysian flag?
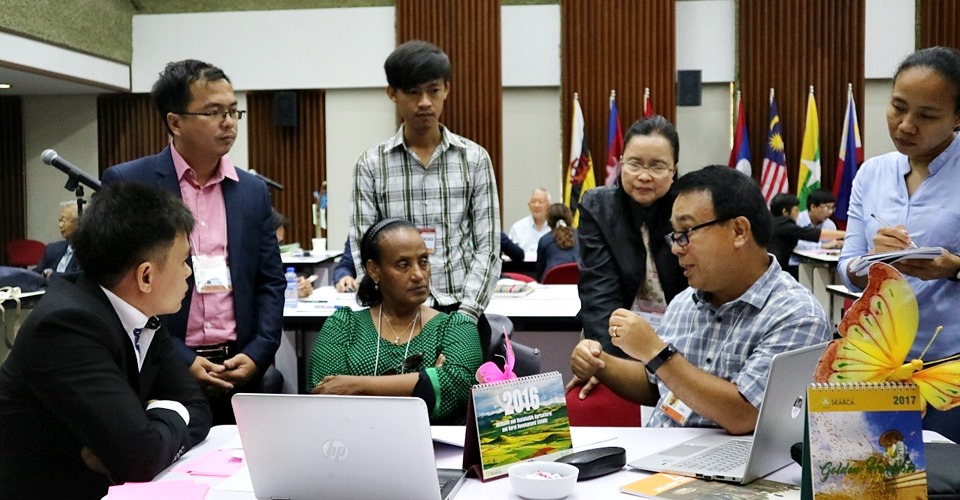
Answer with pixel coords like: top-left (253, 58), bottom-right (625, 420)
top-left (737, 0), bottom-right (868, 193)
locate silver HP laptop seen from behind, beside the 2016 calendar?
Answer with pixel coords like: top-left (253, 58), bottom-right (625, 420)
top-left (232, 394), bottom-right (466, 500)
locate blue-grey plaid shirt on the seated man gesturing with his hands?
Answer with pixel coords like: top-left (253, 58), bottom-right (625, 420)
top-left (646, 255), bottom-right (832, 427)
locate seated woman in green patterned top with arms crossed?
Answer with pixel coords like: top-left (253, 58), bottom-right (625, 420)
top-left (308, 218), bottom-right (482, 424)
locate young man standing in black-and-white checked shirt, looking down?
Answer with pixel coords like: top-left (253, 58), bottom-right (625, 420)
top-left (350, 40), bottom-right (501, 353)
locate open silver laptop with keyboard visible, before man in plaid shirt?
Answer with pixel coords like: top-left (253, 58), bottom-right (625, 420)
top-left (627, 343), bottom-right (827, 484)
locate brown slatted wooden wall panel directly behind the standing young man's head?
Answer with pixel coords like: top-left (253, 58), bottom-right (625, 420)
top-left (396, 0), bottom-right (503, 199)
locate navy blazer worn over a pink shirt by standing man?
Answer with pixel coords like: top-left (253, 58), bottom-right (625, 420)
top-left (102, 146), bottom-right (287, 374)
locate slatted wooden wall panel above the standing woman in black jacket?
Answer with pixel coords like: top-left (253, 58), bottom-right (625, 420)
top-left (560, 0), bottom-right (676, 186)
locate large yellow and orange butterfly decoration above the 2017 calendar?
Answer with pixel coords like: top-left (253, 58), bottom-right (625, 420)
top-left (813, 263), bottom-right (960, 410)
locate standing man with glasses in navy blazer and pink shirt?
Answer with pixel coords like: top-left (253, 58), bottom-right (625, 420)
top-left (102, 60), bottom-right (286, 424)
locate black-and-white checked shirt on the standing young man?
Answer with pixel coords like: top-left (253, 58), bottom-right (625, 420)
top-left (350, 125), bottom-right (501, 320)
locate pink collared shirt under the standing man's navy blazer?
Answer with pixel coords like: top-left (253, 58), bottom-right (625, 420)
top-left (170, 142), bottom-right (239, 347)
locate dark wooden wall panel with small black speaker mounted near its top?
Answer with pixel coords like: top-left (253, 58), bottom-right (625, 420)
top-left (241, 90), bottom-right (324, 249)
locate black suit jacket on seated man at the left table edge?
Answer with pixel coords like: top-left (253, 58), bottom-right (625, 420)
top-left (0, 274), bottom-right (212, 499)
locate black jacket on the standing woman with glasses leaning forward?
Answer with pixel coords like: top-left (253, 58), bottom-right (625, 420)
top-left (577, 180), bottom-right (687, 357)
